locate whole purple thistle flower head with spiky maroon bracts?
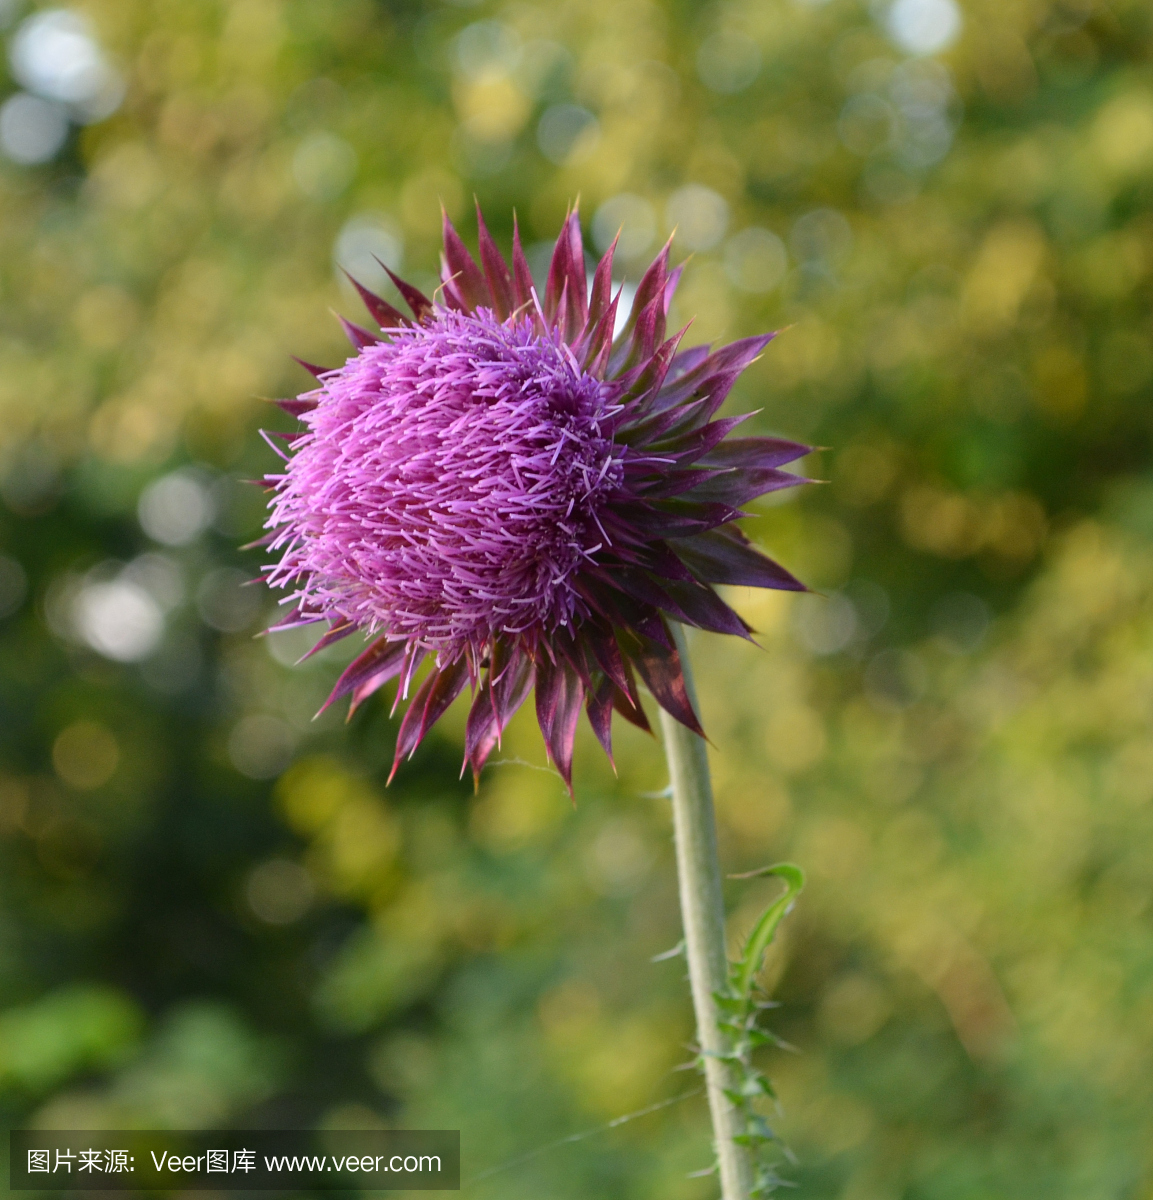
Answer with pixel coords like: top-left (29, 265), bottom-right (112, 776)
top-left (263, 209), bottom-right (809, 788)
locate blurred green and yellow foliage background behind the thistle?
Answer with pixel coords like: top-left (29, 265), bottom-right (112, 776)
top-left (0, 0), bottom-right (1153, 1200)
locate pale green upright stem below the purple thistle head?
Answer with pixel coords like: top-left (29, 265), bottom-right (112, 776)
top-left (661, 623), bottom-right (752, 1200)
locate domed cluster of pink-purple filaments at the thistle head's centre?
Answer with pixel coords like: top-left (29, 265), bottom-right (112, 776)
top-left (269, 308), bottom-right (625, 658)
